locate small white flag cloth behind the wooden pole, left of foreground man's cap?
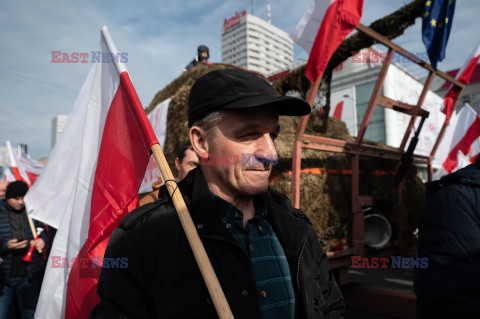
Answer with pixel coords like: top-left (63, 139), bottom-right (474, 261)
top-left (138, 99), bottom-right (170, 194)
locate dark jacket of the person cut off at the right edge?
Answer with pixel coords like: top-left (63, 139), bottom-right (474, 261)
top-left (414, 159), bottom-right (480, 318)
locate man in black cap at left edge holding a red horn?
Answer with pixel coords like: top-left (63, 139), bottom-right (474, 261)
top-left (0, 181), bottom-right (45, 318)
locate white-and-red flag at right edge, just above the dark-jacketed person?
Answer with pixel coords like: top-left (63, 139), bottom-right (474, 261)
top-left (434, 104), bottom-right (480, 179)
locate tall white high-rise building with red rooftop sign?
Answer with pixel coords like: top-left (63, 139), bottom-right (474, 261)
top-left (222, 11), bottom-right (293, 76)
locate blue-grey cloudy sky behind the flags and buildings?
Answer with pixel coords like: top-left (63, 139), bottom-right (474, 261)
top-left (0, 0), bottom-right (480, 159)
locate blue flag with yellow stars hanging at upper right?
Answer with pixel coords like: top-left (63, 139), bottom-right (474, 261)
top-left (422, 0), bottom-right (455, 70)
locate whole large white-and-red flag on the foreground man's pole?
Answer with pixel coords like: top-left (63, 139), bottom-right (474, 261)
top-left (25, 26), bottom-right (158, 319)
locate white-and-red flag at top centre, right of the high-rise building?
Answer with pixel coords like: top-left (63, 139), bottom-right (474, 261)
top-left (291, 0), bottom-right (363, 83)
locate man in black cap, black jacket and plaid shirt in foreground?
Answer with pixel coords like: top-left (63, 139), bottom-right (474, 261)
top-left (91, 70), bottom-right (344, 318)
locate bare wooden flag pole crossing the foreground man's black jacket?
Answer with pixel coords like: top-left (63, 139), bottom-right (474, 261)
top-left (151, 144), bottom-right (234, 319)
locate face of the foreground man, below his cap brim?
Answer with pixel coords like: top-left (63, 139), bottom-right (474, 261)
top-left (202, 108), bottom-right (280, 197)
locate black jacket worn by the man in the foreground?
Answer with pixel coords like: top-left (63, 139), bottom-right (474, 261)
top-left (91, 168), bottom-right (344, 319)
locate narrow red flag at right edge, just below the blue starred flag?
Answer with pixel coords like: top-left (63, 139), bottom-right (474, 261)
top-left (442, 42), bottom-right (480, 123)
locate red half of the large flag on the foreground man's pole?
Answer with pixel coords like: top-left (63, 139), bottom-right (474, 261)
top-left (65, 72), bottom-right (158, 318)
